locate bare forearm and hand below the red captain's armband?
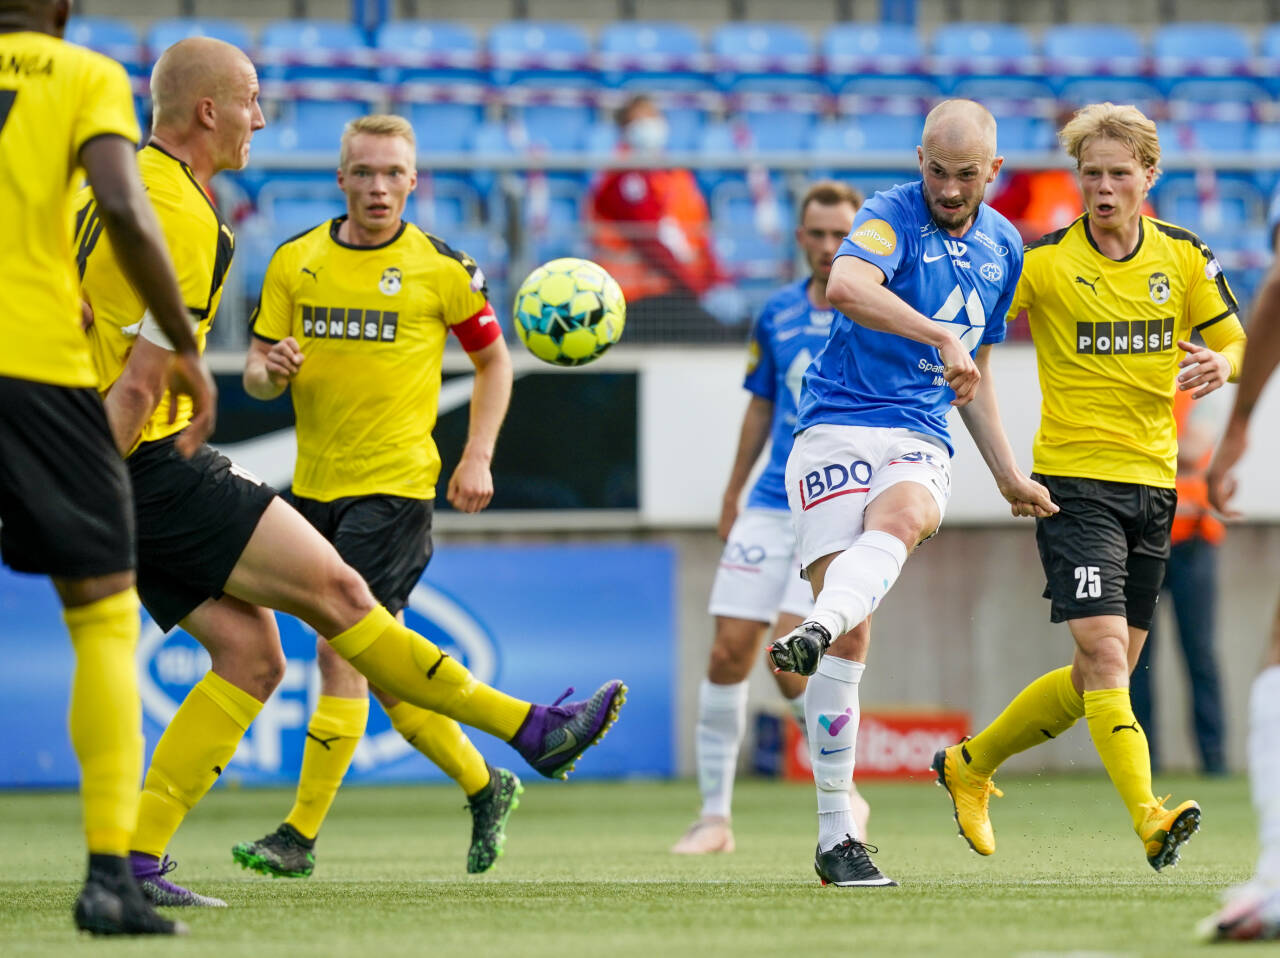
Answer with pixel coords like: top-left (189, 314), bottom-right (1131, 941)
top-left (447, 335), bottom-right (513, 512)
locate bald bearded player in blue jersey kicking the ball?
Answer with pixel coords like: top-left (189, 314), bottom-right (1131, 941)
top-left (769, 100), bottom-right (1056, 886)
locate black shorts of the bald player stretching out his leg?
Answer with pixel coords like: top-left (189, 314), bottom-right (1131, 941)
top-left (127, 435), bottom-right (275, 631)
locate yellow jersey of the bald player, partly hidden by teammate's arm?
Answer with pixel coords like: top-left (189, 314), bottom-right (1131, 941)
top-left (72, 143), bottom-right (236, 442)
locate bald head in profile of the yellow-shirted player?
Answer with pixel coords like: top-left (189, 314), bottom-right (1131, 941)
top-left (151, 37), bottom-right (265, 173)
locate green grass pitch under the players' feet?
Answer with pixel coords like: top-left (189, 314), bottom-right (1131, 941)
top-left (0, 776), bottom-right (1270, 958)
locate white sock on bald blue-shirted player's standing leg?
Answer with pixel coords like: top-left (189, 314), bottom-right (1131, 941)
top-left (804, 656), bottom-right (867, 852)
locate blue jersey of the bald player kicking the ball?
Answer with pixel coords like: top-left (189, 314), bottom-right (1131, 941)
top-left (796, 181), bottom-right (1023, 453)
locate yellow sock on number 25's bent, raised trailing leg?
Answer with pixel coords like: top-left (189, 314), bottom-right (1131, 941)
top-left (965, 666), bottom-right (1084, 779)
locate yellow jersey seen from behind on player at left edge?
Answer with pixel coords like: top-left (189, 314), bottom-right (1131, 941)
top-left (0, 32), bottom-right (138, 387)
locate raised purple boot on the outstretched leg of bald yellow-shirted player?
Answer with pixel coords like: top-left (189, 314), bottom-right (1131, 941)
top-left (511, 679), bottom-right (627, 779)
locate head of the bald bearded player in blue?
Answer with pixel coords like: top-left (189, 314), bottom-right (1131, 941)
top-left (916, 100), bottom-right (1004, 236)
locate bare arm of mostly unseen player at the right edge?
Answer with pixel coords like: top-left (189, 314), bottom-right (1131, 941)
top-left (1207, 260), bottom-right (1280, 517)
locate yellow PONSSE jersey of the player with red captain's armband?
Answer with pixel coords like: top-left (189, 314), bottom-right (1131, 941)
top-left (251, 216), bottom-right (493, 502)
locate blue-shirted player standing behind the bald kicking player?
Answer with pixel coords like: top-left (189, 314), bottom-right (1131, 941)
top-left (671, 181), bottom-right (869, 854)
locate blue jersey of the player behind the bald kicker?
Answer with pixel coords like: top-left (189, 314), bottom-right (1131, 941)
top-left (742, 278), bottom-right (836, 511)
